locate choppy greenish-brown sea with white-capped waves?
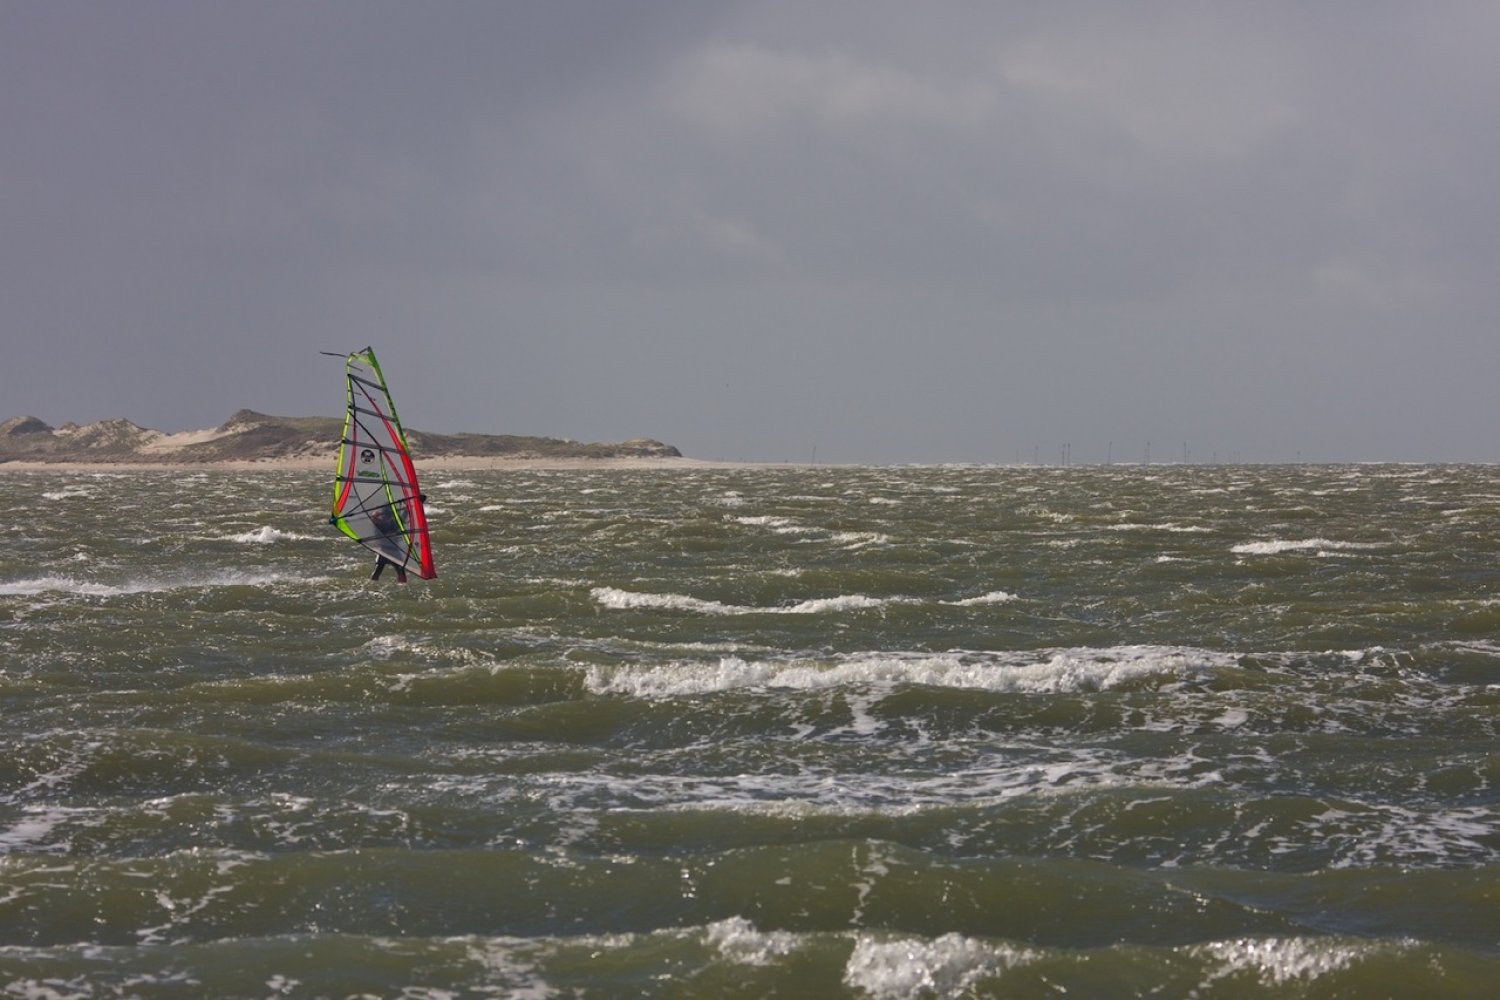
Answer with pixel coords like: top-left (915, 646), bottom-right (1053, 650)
top-left (0, 456), bottom-right (1500, 1000)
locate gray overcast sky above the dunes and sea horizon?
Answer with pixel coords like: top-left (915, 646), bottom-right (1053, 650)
top-left (0, 0), bottom-right (1500, 462)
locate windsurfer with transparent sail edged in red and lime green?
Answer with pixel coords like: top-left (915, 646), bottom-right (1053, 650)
top-left (324, 348), bottom-right (438, 582)
